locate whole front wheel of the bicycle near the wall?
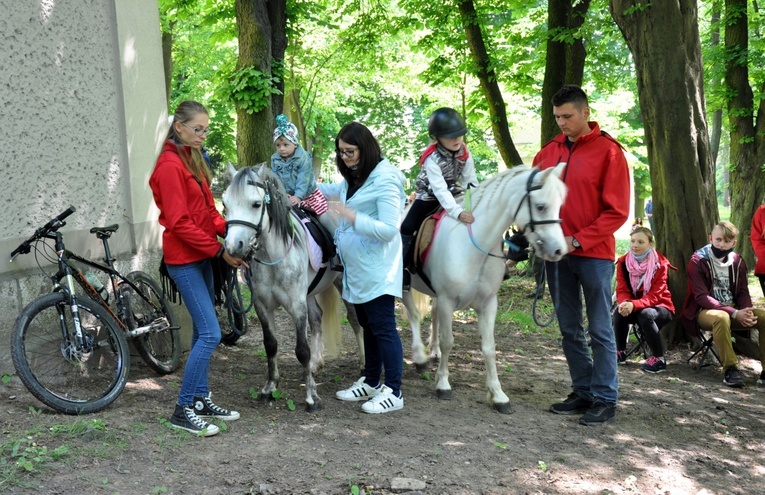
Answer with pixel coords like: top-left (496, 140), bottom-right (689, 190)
top-left (11, 292), bottom-right (130, 414)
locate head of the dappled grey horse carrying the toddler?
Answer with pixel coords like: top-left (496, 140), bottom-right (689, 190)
top-left (223, 162), bottom-right (292, 258)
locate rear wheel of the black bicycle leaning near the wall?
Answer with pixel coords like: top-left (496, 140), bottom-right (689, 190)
top-left (120, 272), bottom-right (181, 375)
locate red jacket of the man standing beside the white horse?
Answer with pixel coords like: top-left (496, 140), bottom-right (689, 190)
top-left (534, 122), bottom-right (630, 260)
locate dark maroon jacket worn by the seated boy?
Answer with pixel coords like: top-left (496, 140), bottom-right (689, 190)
top-left (682, 244), bottom-right (752, 334)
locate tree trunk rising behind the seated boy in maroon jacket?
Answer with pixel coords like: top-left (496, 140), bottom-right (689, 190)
top-left (725, 0), bottom-right (765, 269)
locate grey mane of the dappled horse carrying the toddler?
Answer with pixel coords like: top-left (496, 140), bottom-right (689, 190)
top-left (231, 163), bottom-right (300, 244)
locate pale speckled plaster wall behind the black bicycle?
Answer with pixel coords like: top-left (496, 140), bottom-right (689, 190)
top-left (0, 0), bottom-right (188, 373)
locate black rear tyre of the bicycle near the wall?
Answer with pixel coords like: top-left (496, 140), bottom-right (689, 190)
top-left (123, 271), bottom-right (181, 375)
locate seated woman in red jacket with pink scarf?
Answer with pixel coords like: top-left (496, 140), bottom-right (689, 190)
top-left (614, 227), bottom-right (676, 373)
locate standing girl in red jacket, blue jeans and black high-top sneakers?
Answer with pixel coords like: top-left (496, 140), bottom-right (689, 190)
top-left (149, 101), bottom-right (244, 436)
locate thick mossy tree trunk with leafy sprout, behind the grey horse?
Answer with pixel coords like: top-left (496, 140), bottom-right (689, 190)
top-left (235, 0), bottom-right (275, 167)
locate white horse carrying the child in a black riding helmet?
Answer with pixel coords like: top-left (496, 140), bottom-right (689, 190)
top-left (403, 164), bottom-right (567, 414)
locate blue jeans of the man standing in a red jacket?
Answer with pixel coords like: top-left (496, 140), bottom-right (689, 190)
top-left (546, 256), bottom-right (619, 405)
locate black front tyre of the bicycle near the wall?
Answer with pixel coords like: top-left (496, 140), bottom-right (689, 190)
top-left (11, 292), bottom-right (130, 414)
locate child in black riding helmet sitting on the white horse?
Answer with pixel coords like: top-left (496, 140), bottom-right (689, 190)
top-left (401, 107), bottom-right (478, 290)
